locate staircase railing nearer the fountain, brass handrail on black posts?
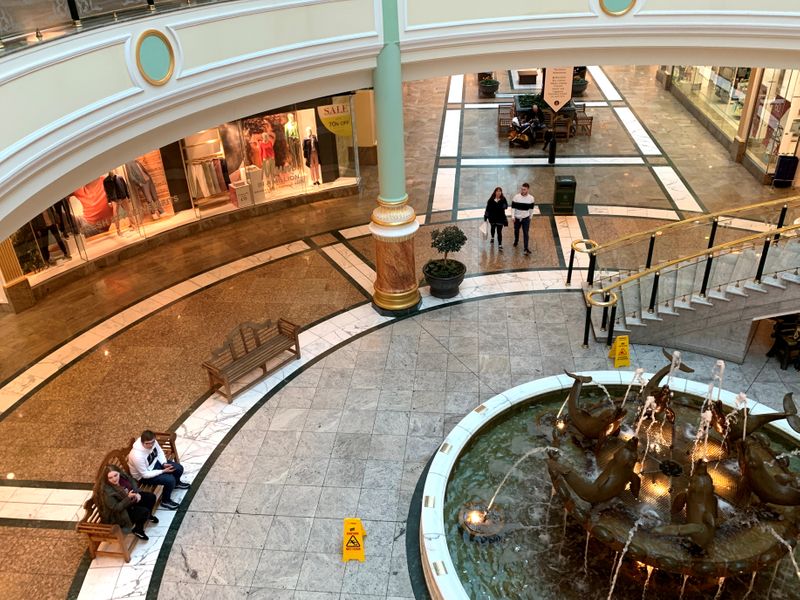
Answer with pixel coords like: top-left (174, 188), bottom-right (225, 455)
top-left (583, 223), bottom-right (800, 346)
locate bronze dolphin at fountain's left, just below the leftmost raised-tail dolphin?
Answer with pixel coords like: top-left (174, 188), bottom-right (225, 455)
top-left (547, 437), bottom-right (642, 504)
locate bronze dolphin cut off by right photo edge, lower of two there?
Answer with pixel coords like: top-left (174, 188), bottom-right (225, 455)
top-left (739, 437), bottom-right (800, 506)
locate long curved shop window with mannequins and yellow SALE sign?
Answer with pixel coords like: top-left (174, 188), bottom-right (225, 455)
top-left (5, 95), bottom-right (358, 285)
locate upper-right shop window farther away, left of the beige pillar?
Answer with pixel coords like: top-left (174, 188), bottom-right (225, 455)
top-left (672, 66), bottom-right (751, 140)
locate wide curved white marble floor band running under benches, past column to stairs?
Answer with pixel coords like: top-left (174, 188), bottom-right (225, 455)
top-left (72, 276), bottom-right (580, 600)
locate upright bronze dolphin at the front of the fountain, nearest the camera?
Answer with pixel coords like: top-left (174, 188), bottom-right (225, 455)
top-left (653, 460), bottom-right (717, 549)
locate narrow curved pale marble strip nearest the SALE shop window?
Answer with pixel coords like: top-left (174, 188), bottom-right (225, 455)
top-left (0, 241), bottom-right (309, 419)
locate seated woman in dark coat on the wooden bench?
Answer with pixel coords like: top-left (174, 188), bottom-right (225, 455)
top-left (95, 465), bottom-right (158, 540)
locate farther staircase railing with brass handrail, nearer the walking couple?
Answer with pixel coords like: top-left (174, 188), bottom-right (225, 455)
top-left (567, 196), bottom-right (800, 287)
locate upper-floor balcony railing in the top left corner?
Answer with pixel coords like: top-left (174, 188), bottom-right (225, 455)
top-left (0, 0), bottom-right (232, 56)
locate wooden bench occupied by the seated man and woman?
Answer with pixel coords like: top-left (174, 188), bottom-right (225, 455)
top-left (75, 432), bottom-right (180, 562)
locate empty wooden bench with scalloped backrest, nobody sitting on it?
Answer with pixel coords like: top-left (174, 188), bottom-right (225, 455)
top-left (203, 319), bottom-right (300, 402)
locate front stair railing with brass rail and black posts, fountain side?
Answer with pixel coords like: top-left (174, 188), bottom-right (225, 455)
top-left (583, 224), bottom-right (800, 346)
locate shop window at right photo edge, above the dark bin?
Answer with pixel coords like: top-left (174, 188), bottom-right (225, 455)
top-left (747, 69), bottom-right (800, 173)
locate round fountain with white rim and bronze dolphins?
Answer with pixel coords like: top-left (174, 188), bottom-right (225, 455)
top-left (420, 360), bottom-right (800, 600)
